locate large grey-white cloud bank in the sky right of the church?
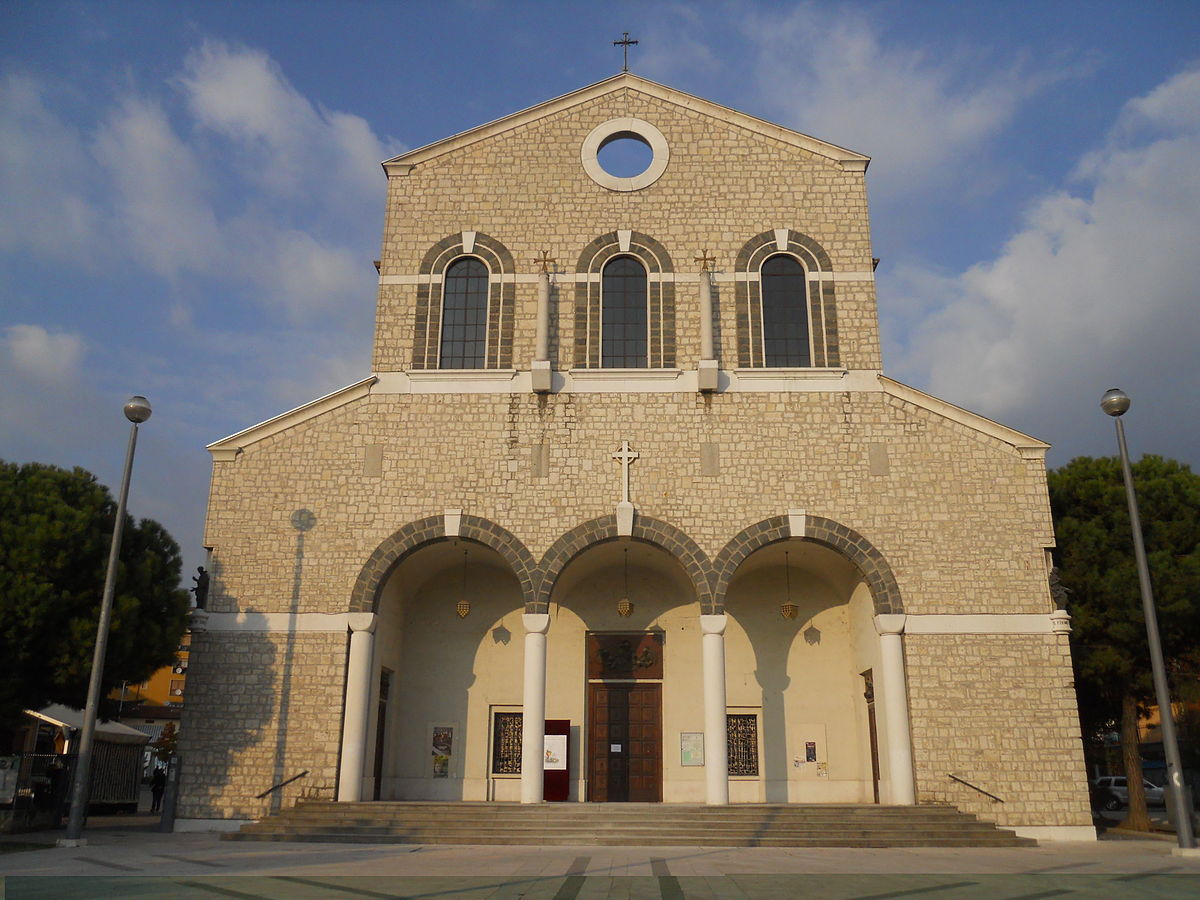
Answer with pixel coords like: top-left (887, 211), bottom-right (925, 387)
top-left (881, 70), bottom-right (1200, 458)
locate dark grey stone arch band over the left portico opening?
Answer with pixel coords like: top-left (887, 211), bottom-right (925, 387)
top-left (349, 515), bottom-right (540, 612)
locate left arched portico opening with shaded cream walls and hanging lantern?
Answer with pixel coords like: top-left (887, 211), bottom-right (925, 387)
top-left (364, 538), bottom-right (524, 800)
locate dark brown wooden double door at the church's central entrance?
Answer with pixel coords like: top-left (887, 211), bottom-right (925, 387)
top-left (588, 682), bottom-right (662, 803)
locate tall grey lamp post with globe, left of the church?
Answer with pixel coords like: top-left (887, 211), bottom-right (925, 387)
top-left (59, 396), bottom-right (150, 847)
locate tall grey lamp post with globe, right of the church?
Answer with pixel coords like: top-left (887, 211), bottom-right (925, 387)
top-left (1100, 388), bottom-right (1196, 851)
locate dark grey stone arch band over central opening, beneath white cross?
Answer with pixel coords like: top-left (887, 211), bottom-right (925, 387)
top-left (527, 516), bottom-right (714, 614)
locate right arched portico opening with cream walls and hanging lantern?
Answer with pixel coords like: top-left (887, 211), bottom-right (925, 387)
top-left (725, 539), bottom-right (878, 803)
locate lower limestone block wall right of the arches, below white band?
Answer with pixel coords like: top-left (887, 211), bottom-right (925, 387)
top-left (905, 634), bottom-right (1092, 827)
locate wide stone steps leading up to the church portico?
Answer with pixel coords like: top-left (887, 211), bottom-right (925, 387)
top-left (222, 800), bottom-right (1037, 847)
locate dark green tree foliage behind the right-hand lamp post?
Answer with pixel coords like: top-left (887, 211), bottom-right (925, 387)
top-left (1049, 456), bottom-right (1200, 731)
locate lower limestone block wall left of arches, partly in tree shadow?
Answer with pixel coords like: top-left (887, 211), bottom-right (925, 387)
top-left (178, 631), bottom-right (346, 818)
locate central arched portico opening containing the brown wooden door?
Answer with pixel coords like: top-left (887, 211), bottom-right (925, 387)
top-left (546, 539), bottom-right (704, 803)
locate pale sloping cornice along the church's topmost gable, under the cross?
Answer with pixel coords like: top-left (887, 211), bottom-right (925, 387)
top-left (383, 72), bottom-right (871, 174)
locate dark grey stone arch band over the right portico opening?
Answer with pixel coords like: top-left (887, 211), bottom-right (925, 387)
top-left (713, 516), bottom-right (904, 616)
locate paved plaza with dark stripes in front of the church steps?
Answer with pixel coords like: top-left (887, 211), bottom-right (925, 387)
top-left (0, 817), bottom-right (1200, 900)
